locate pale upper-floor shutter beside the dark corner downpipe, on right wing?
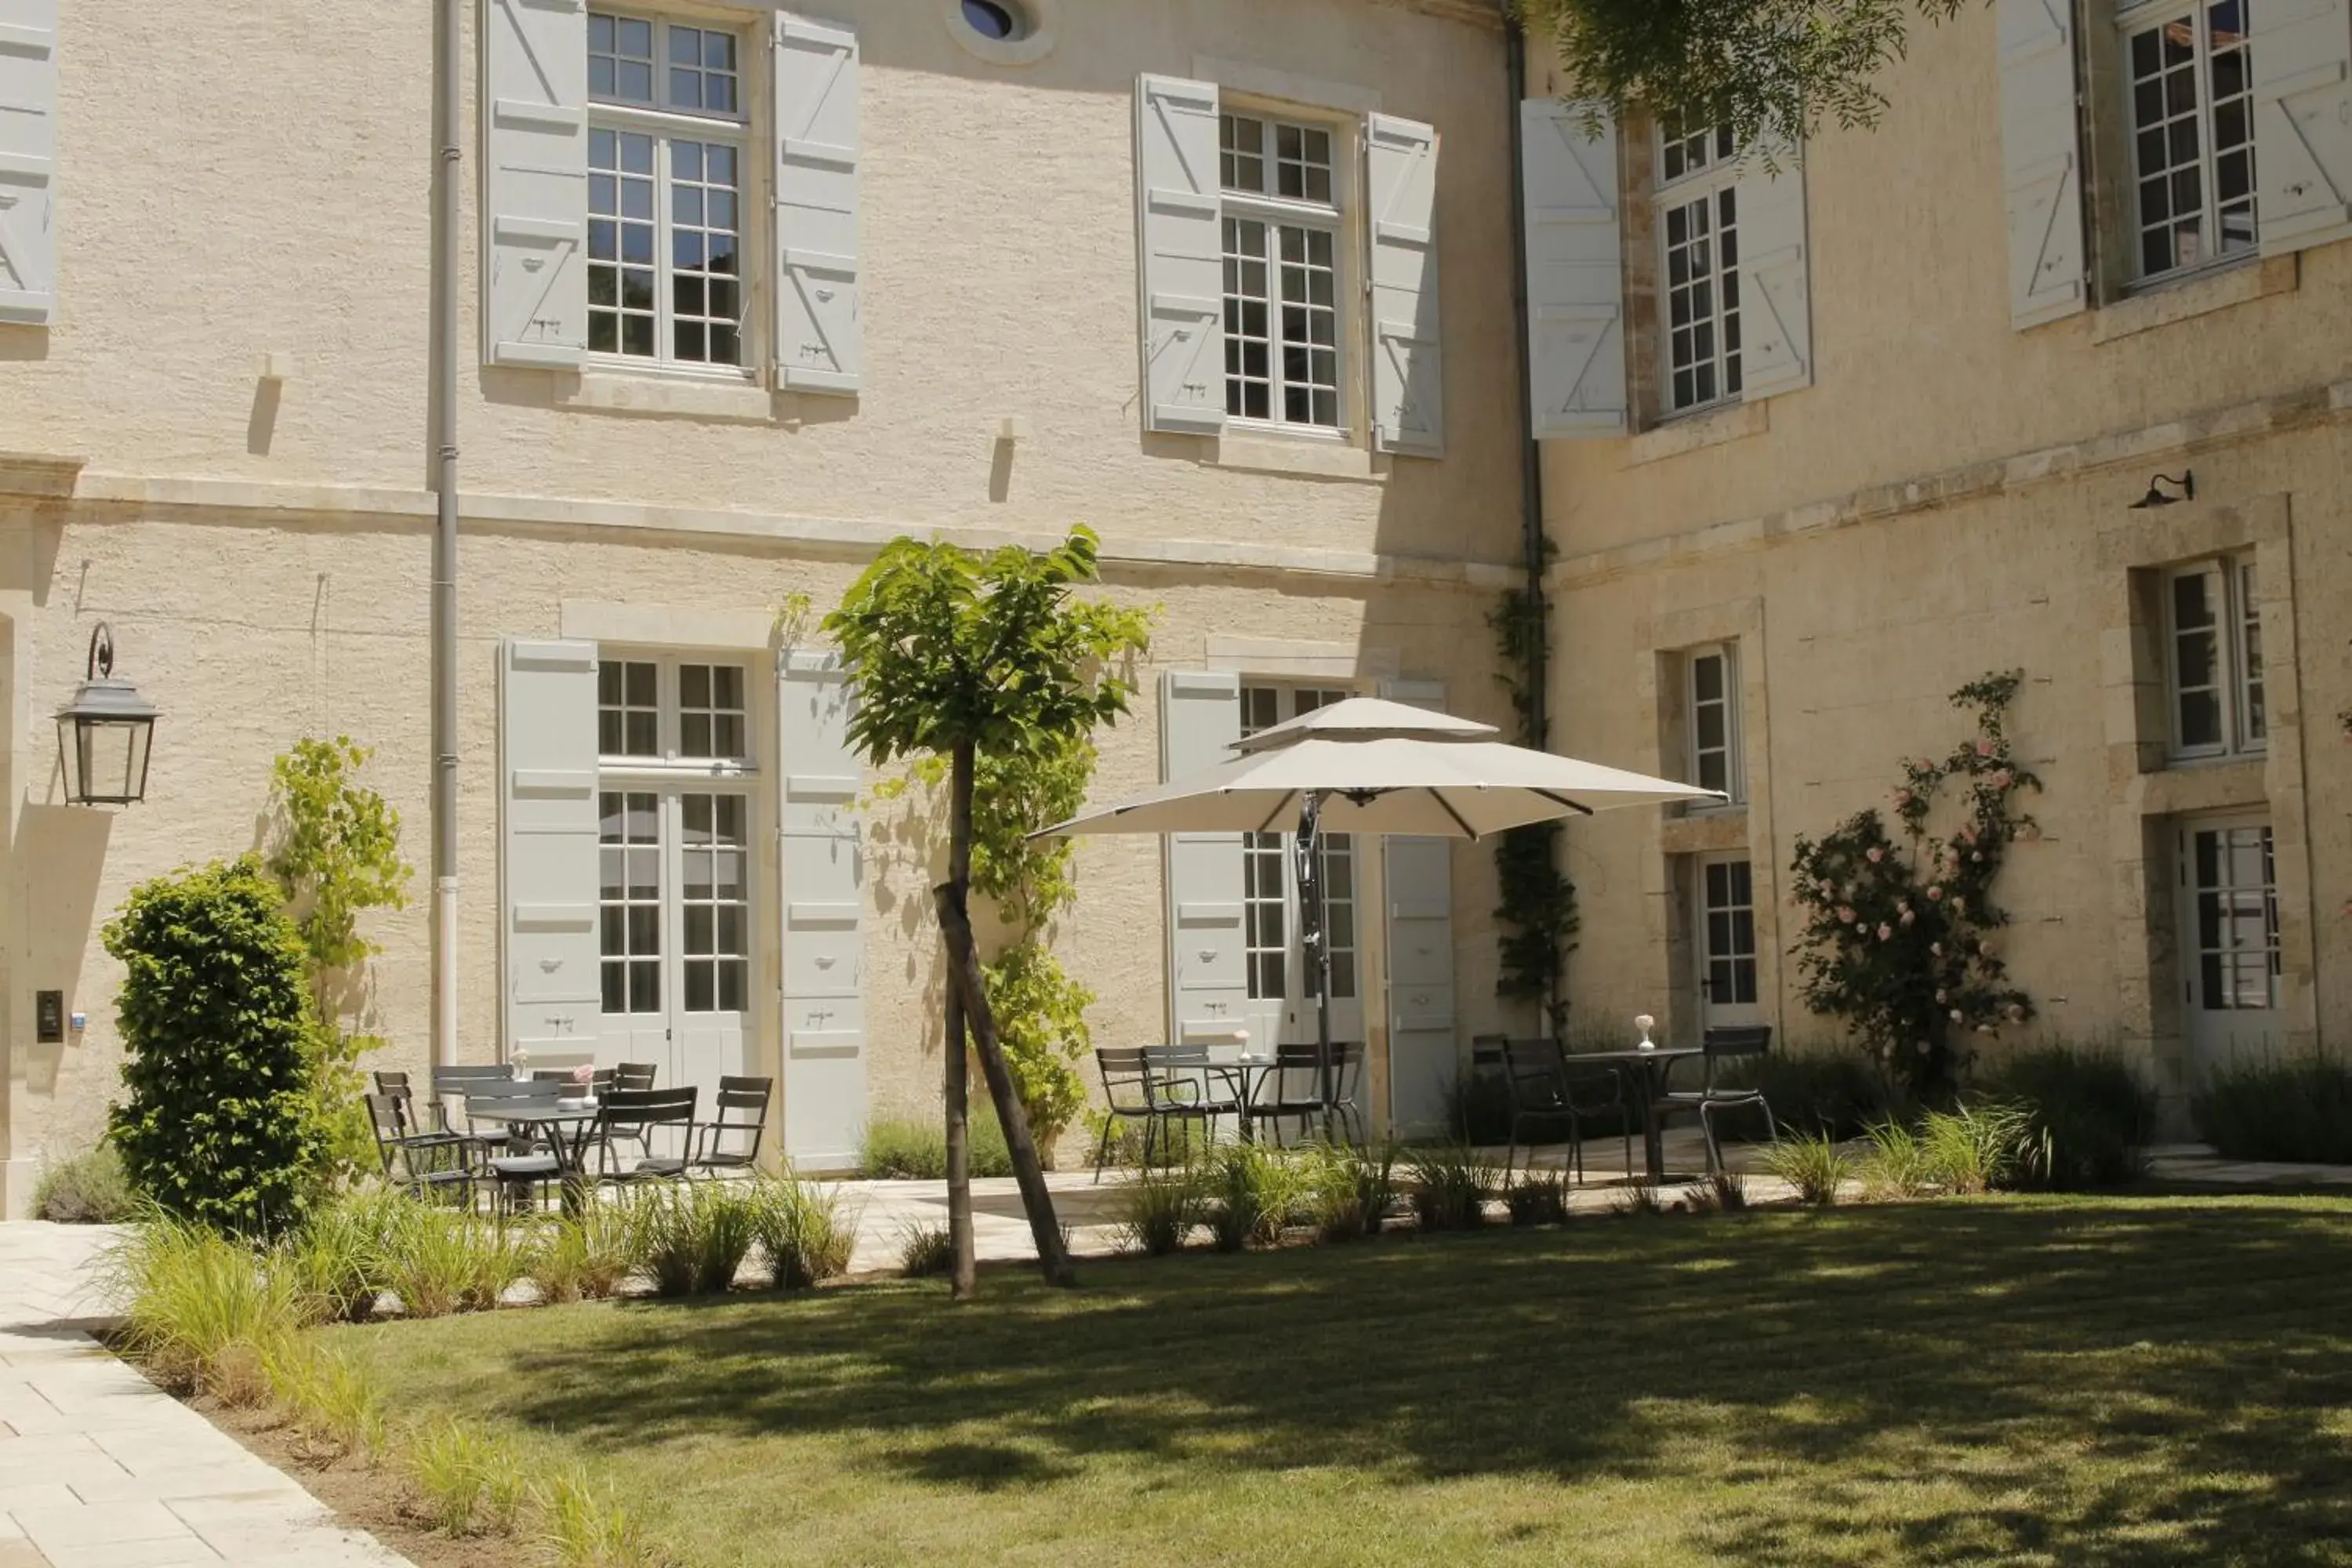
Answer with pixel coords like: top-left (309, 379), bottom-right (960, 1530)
top-left (1519, 99), bottom-right (1630, 437)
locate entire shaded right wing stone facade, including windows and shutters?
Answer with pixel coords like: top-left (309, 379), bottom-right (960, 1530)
top-left (1529, 0), bottom-right (2352, 1126)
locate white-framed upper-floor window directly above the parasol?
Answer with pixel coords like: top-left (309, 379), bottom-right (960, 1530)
top-left (1218, 113), bottom-right (1345, 430)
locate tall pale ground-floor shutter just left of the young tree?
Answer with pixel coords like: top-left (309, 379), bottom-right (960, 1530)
top-left (776, 649), bottom-right (866, 1171)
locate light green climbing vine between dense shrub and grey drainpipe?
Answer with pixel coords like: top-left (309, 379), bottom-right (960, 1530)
top-left (268, 736), bottom-right (414, 1171)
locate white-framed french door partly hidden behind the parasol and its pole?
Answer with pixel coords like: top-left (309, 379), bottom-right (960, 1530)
top-left (1242, 687), bottom-right (1364, 1048)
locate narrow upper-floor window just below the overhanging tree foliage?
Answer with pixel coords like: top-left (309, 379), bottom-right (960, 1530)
top-left (1656, 127), bottom-right (1740, 414)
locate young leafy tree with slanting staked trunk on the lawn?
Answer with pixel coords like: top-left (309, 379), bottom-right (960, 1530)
top-left (823, 529), bottom-right (1148, 1298)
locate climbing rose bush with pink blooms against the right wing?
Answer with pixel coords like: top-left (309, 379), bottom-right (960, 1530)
top-left (1792, 670), bottom-right (2042, 1095)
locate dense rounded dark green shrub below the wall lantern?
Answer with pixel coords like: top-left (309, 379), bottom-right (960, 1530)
top-left (103, 855), bottom-right (327, 1234)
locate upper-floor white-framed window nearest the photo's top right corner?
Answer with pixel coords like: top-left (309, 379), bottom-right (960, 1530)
top-left (2117, 0), bottom-right (2249, 278)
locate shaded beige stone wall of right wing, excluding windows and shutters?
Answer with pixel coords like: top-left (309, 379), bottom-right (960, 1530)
top-left (1545, 7), bottom-right (2352, 1114)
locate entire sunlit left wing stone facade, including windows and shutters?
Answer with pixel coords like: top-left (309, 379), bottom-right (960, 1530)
top-left (0, 0), bottom-right (1522, 1208)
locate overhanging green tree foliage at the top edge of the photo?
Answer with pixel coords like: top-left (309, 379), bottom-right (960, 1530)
top-left (1512, 0), bottom-right (1969, 146)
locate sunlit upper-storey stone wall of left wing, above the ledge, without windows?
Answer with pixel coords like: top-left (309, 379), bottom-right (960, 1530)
top-left (13, 0), bottom-right (1519, 573)
